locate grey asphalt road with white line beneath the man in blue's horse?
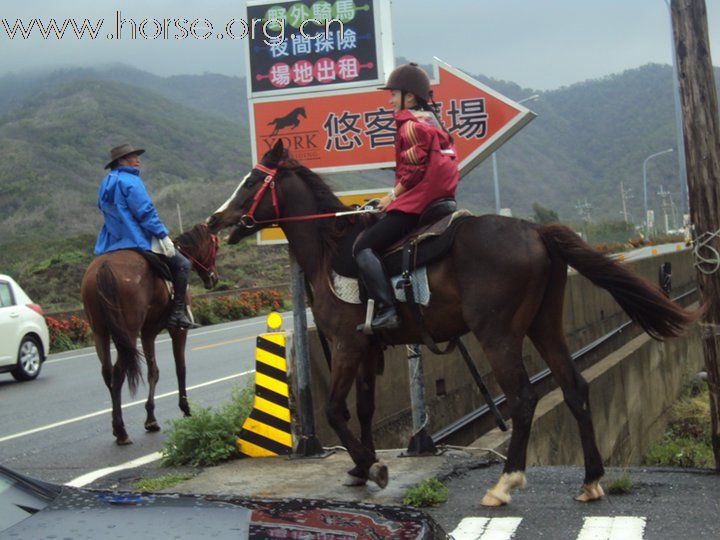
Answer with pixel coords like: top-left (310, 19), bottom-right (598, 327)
top-left (0, 313), bottom-right (300, 483)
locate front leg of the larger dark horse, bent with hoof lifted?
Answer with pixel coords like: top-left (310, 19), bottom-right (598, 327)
top-left (325, 348), bottom-right (387, 488)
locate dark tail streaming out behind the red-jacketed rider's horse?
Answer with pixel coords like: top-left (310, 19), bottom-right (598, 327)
top-left (538, 225), bottom-right (702, 339)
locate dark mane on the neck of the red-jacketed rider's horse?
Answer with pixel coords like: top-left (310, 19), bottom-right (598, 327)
top-left (282, 157), bottom-right (355, 257)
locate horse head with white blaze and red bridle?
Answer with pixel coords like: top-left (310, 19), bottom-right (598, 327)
top-left (207, 139), bottom-right (288, 244)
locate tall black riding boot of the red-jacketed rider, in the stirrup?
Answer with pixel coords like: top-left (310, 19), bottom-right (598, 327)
top-left (355, 249), bottom-right (400, 330)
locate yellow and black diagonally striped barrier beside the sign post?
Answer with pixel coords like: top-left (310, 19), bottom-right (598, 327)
top-left (235, 313), bottom-right (292, 457)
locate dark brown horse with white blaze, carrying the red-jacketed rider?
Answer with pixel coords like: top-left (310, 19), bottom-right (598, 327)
top-left (208, 143), bottom-right (697, 506)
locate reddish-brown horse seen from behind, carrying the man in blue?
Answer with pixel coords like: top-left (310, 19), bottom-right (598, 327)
top-left (81, 224), bottom-right (218, 445)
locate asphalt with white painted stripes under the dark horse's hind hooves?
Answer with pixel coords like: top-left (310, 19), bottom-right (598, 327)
top-left (428, 465), bottom-right (720, 540)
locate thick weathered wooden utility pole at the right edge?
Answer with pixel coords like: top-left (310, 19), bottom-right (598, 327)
top-left (670, 0), bottom-right (720, 472)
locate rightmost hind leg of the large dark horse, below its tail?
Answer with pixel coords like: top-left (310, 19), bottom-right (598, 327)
top-left (529, 312), bottom-right (605, 502)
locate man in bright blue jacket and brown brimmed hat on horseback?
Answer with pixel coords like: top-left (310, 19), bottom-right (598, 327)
top-left (94, 144), bottom-right (193, 328)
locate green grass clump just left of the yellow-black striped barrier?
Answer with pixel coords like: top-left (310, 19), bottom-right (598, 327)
top-left (161, 383), bottom-right (254, 467)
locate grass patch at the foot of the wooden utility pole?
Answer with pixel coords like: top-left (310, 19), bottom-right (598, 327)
top-left (643, 381), bottom-right (715, 469)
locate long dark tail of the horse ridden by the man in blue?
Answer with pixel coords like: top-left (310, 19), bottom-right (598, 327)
top-left (96, 262), bottom-right (142, 396)
